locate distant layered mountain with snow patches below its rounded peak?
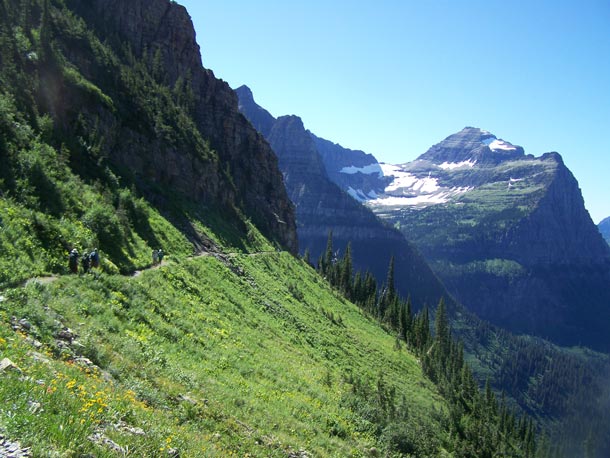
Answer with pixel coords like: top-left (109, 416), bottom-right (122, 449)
top-left (367, 128), bottom-right (610, 350)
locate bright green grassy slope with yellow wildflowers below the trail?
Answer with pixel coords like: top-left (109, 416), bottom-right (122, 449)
top-left (0, 242), bottom-right (443, 456)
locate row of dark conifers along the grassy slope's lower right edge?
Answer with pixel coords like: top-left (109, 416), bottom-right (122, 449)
top-left (304, 232), bottom-right (536, 457)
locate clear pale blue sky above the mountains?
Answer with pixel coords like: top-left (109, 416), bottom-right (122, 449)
top-left (179, 0), bottom-right (610, 223)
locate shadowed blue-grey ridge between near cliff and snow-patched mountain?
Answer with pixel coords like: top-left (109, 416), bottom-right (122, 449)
top-left (236, 87), bottom-right (452, 307)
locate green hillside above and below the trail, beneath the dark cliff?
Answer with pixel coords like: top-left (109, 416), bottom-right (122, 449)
top-left (0, 101), bottom-right (520, 456)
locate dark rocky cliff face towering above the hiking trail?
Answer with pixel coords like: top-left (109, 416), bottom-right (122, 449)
top-left (59, 0), bottom-right (297, 252)
